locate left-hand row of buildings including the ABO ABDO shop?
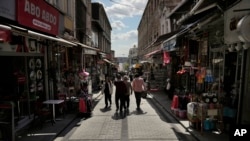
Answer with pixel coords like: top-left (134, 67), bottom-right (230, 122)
top-left (0, 0), bottom-right (111, 140)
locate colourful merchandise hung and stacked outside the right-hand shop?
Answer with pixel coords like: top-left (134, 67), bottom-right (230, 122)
top-left (180, 27), bottom-right (226, 133)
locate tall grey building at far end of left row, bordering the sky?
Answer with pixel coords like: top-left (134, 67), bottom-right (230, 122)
top-left (92, 3), bottom-right (114, 80)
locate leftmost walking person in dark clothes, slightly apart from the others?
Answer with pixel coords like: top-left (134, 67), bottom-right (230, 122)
top-left (102, 76), bottom-right (113, 108)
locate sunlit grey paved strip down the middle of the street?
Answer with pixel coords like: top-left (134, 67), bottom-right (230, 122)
top-left (63, 90), bottom-right (194, 141)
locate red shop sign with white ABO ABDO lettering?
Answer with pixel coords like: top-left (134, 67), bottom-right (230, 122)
top-left (17, 0), bottom-right (59, 35)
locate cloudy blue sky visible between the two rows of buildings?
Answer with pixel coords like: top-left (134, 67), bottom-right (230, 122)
top-left (92, 0), bottom-right (148, 57)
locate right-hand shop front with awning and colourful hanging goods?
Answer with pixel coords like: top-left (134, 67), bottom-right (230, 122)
top-left (168, 10), bottom-right (230, 131)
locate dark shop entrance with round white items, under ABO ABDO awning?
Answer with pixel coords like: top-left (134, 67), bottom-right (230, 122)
top-left (0, 56), bottom-right (45, 125)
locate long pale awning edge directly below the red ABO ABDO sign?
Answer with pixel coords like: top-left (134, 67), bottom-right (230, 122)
top-left (0, 24), bottom-right (76, 46)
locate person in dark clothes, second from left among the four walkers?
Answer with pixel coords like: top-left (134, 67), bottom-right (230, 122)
top-left (114, 74), bottom-right (127, 112)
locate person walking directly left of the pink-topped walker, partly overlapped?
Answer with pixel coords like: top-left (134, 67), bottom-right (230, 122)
top-left (123, 76), bottom-right (133, 111)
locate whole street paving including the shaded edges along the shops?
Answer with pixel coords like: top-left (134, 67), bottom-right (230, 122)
top-left (16, 91), bottom-right (229, 141)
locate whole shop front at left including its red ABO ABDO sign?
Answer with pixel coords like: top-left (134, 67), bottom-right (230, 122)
top-left (0, 0), bottom-right (75, 137)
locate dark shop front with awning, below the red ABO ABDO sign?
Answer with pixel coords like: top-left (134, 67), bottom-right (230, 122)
top-left (0, 24), bottom-right (76, 137)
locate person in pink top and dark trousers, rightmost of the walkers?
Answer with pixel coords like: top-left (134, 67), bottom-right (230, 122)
top-left (132, 74), bottom-right (146, 111)
